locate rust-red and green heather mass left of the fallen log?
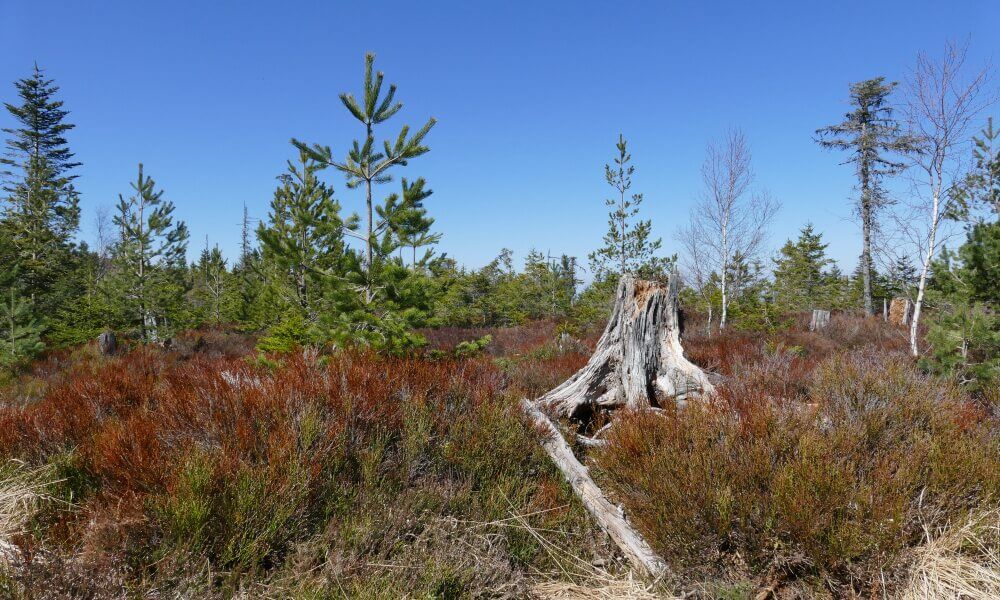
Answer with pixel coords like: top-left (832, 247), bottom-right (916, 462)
top-left (0, 349), bottom-right (589, 593)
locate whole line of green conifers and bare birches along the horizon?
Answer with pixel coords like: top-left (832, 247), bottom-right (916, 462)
top-left (0, 45), bottom-right (1000, 379)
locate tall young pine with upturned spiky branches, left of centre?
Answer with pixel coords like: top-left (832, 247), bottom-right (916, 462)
top-left (292, 52), bottom-right (436, 304)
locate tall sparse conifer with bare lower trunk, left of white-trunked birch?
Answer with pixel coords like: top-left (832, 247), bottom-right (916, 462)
top-left (816, 77), bottom-right (917, 314)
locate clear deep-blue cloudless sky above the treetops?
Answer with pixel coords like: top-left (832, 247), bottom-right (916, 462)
top-left (0, 0), bottom-right (1000, 270)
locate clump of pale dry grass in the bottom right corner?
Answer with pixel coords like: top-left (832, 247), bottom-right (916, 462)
top-left (900, 509), bottom-right (1000, 600)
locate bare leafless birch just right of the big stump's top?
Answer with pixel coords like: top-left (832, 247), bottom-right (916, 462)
top-left (678, 129), bottom-right (779, 329)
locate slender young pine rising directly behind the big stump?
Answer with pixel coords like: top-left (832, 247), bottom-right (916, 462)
top-left (590, 134), bottom-right (663, 279)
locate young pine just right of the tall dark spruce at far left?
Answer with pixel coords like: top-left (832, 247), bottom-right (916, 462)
top-left (109, 163), bottom-right (188, 341)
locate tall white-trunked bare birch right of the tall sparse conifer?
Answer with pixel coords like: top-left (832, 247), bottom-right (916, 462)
top-left (899, 41), bottom-right (994, 356)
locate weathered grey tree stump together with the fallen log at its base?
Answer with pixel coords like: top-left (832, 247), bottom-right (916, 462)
top-left (522, 275), bottom-right (714, 577)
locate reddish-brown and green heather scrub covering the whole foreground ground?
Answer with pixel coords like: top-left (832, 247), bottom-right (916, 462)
top-left (0, 315), bottom-right (1000, 598)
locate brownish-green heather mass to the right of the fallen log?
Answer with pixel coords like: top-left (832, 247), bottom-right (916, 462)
top-left (597, 351), bottom-right (1000, 592)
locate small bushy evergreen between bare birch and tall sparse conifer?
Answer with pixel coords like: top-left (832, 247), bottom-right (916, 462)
top-left (773, 223), bottom-right (833, 310)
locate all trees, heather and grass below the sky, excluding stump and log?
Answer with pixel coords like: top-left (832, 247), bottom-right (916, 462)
top-left (0, 45), bottom-right (1000, 598)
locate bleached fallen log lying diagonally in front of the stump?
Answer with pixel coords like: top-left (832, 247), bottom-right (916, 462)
top-left (521, 399), bottom-right (667, 578)
